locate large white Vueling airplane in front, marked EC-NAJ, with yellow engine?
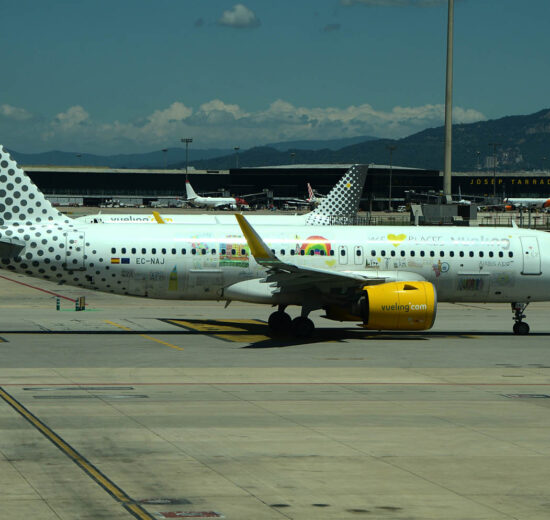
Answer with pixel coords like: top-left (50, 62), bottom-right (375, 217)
top-left (0, 146), bottom-right (550, 337)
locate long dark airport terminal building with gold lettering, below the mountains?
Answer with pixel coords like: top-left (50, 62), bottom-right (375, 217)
top-left (23, 164), bottom-right (550, 210)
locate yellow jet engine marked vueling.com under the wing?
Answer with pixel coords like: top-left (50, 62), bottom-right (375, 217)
top-left (326, 281), bottom-right (437, 330)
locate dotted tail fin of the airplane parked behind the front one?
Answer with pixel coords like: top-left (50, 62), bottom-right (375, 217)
top-left (306, 164), bottom-right (369, 225)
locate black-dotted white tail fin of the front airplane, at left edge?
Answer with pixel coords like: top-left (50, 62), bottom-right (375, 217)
top-left (0, 145), bottom-right (70, 226)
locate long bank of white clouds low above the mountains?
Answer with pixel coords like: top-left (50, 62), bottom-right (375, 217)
top-left (0, 99), bottom-right (486, 154)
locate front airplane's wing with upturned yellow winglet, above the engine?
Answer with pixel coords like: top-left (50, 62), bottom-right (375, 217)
top-left (235, 214), bottom-right (424, 290)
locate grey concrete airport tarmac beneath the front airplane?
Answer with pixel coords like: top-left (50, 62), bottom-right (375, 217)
top-left (0, 271), bottom-right (550, 520)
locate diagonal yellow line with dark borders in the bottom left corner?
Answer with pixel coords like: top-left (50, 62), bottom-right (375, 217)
top-left (0, 388), bottom-right (155, 520)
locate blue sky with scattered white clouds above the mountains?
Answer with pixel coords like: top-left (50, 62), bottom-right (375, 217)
top-left (0, 0), bottom-right (550, 154)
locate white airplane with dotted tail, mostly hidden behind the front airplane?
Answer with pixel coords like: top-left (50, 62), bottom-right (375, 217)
top-left (75, 164), bottom-right (369, 226)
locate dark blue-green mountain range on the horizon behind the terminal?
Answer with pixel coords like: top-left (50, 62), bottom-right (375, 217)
top-left (7, 109), bottom-right (550, 171)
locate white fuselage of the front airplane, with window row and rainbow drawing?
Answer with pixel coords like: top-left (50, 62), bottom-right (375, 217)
top-left (1, 223), bottom-right (550, 302)
